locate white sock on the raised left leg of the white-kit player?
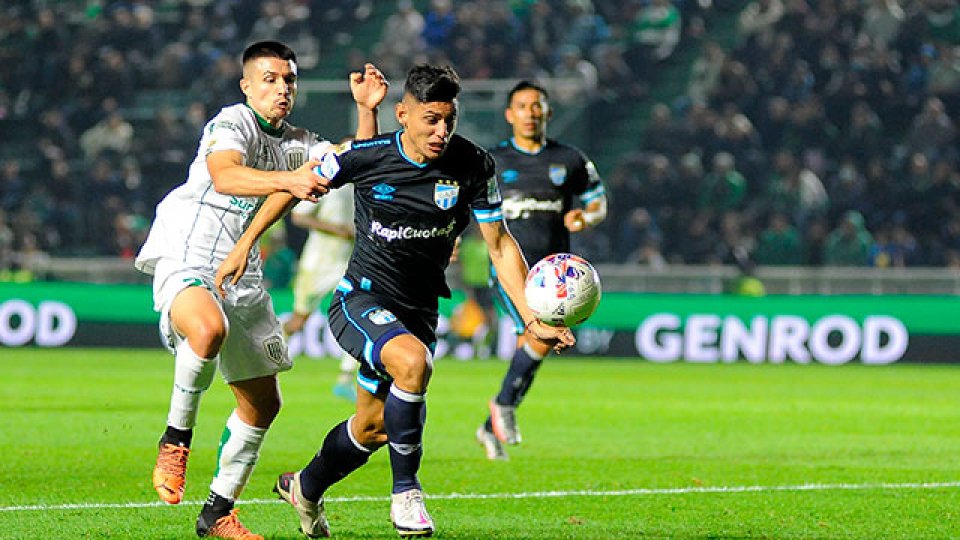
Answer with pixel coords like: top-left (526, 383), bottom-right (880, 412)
top-left (167, 339), bottom-right (220, 429)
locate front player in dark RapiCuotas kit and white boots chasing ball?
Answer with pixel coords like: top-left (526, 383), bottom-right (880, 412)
top-left (216, 65), bottom-right (575, 537)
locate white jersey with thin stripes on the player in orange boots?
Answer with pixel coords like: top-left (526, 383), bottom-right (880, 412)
top-left (135, 103), bottom-right (331, 277)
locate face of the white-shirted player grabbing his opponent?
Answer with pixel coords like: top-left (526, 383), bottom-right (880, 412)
top-left (240, 57), bottom-right (297, 127)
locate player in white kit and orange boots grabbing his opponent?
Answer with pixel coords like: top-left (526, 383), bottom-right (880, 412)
top-left (135, 41), bottom-right (387, 540)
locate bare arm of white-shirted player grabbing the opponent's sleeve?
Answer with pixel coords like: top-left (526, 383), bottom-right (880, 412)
top-left (207, 150), bottom-right (327, 202)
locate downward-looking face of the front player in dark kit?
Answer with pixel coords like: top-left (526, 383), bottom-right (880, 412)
top-left (397, 96), bottom-right (457, 163)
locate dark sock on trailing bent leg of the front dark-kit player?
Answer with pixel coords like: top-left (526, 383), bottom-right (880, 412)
top-left (300, 420), bottom-right (372, 501)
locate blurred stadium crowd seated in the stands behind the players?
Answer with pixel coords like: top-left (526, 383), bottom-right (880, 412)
top-left (0, 0), bottom-right (960, 278)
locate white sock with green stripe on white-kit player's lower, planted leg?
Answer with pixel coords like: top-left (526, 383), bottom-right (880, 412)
top-left (210, 410), bottom-right (267, 501)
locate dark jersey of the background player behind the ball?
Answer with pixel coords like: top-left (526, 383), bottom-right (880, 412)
top-left (490, 139), bottom-right (605, 266)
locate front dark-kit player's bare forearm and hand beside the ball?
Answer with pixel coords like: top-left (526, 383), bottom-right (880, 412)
top-left (479, 221), bottom-right (576, 352)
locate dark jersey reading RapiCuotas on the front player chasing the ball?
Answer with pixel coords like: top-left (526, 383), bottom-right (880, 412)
top-left (320, 131), bottom-right (503, 310)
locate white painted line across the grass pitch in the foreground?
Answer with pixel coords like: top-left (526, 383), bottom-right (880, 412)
top-left (0, 481), bottom-right (960, 512)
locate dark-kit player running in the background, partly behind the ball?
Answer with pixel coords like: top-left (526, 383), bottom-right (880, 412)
top-left (476, 81), bottom-right (607, 459)
